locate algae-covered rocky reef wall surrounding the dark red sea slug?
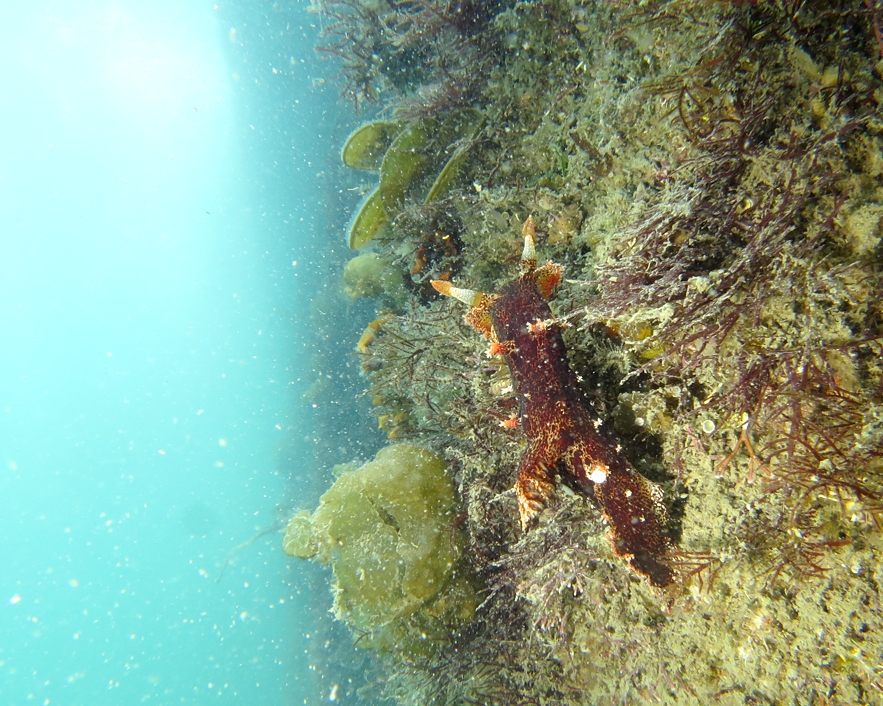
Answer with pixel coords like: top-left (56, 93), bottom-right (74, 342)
top-left (296, 0), bottom-right (883, 705)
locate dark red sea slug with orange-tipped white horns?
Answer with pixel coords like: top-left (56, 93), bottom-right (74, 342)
top-left (432, 218), bottom-right (674, 588)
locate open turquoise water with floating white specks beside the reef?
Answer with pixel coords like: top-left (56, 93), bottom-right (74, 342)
top-left (0, 0), bottom-right (366, 704)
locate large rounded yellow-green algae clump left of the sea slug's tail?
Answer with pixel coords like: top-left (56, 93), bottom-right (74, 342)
top-left (283, 444), bottom-right (476, 652)
